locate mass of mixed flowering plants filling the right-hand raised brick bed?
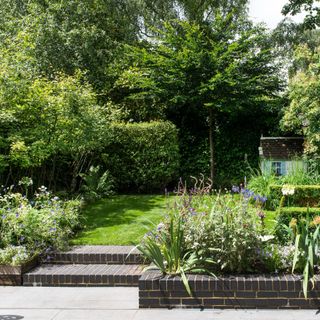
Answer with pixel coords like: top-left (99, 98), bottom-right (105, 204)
top-left (139, 179), bottom-right (320, 296)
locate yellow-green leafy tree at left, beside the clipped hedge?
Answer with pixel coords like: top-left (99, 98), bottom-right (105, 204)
top-left (0, 39), bottom-right (108, 191)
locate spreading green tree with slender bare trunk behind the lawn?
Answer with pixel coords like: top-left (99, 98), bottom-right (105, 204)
top-left (115, 19), bottom-right (280, 179)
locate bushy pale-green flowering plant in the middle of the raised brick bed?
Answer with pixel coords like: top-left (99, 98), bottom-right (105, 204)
top-left (185, 190), bottom-right (264, 273)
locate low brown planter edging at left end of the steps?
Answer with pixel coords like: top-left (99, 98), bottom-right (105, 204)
top-left (0, 256), bottom-right (39, 286)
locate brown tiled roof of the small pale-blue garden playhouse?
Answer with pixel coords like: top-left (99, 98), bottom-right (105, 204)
top-left (259, 137), bottom-right (304, 160)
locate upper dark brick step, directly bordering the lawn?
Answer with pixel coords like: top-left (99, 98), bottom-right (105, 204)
top-left (50, 246), bottom-right (143, 264)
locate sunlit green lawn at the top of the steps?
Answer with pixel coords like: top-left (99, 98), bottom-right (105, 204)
top-left (71, 195), bottom-right (167, 245)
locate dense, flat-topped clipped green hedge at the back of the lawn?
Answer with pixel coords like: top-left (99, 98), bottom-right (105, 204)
top-left (103, 122), bottom-right (179, 192)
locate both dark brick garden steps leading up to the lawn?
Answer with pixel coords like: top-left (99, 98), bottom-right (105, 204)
top-left (23, 246), bottom-right (145, 287)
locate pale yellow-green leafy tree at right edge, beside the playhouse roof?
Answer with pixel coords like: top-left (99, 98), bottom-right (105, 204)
top-left (282, 45), bottom-right (320, 158)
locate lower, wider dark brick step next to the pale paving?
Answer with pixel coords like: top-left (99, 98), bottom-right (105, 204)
top-left (23, 264), bottom-right (144, 287)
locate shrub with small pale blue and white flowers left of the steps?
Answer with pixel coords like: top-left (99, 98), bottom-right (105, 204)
top-left (0, 180), bottom-right (80, 263)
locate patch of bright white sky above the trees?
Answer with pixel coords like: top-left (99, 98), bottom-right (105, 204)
top-left (249, 0), bottom-right (303, 29)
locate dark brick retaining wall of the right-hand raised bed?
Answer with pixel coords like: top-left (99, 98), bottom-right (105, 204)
top-left (139, 272), bottom-right (320, 309)
